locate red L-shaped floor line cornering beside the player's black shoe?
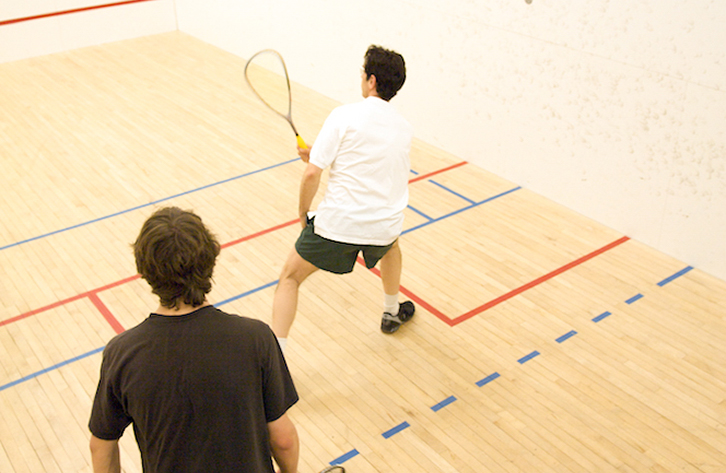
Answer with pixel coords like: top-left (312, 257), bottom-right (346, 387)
top-left (358, 237), bottom-right (630, 327)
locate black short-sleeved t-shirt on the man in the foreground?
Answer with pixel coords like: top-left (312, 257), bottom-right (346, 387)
top-left (89, 306), bottom-right (298, 473)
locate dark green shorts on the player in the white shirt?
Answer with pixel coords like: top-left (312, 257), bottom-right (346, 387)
top-left (295, 221), bottom-right (396, 274)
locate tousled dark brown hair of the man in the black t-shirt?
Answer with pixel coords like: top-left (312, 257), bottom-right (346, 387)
top-left (133, 207), bottom-right (220, 309)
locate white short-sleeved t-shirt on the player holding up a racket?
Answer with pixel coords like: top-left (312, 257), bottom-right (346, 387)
top-left (310, 97), bottom-right (413, 246)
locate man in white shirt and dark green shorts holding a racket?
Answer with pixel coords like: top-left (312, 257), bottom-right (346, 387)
top-left (272, 46), bottom-right (415, 347)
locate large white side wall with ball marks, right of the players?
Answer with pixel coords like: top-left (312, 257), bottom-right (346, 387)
top-left (176, 0), bottom-right (726, 279)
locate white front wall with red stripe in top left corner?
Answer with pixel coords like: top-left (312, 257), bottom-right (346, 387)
top-left (0, 0), bottom-right (177, 63)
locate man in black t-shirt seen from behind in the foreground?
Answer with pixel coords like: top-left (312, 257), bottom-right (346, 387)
top-left (89, 208), bottom-right (299, 473)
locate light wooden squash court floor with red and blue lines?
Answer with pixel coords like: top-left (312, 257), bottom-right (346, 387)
top-left (0, 33), bottom-right (726, 473)
